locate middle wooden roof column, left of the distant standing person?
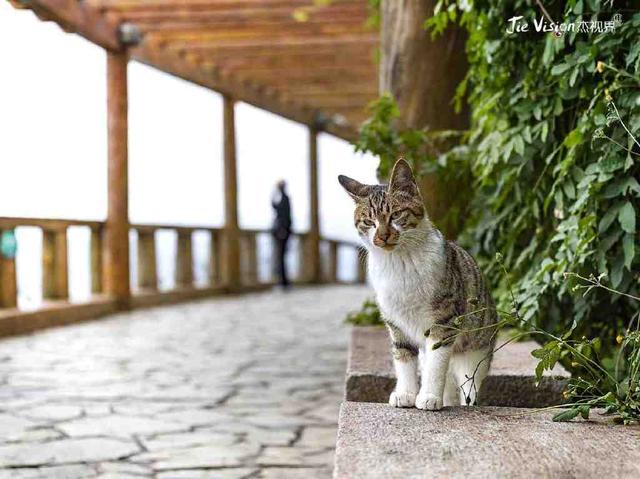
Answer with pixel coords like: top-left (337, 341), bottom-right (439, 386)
top-left (221, 96), bottom-right (240, 289)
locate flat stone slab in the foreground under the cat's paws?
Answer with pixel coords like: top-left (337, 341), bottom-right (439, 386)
top-left (334, 402), bottom-right (640, 479)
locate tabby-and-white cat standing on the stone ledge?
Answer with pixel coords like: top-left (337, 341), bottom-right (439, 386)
top-left (338, 158), bottom-right (497, 410)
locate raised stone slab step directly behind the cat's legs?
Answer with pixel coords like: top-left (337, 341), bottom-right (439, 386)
top-left (345, 326), bottom-right (570, 407)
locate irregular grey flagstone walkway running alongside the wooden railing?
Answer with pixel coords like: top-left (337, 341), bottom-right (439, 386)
top-left (0, 286), bottom-right (368, 479)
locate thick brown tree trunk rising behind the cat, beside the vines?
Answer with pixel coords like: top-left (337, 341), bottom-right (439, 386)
top-left (380, 0), bottom-right (469, 237)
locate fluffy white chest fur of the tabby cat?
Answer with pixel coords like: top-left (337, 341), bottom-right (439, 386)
top-left (368, 232), bottom-right (445, 344)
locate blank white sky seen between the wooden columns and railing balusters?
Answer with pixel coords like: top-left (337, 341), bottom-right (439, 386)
top-left (0, 2), bottom-right (377, 308)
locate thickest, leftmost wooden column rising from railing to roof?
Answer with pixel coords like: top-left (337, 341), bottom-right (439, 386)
top-left (103, 52), bottom-right (131, 308)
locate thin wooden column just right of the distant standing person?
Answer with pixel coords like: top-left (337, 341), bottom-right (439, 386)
top-left (304, 127), bottom-right (321, 283)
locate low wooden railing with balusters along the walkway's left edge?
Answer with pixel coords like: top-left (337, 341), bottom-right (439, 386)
top-left (0, 217), bottom-right (364, 335)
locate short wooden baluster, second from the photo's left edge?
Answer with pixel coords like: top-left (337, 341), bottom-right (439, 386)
top-left (42, 228), bottom-right (69, 299)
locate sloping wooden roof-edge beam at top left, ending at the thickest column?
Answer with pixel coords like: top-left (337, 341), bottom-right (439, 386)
top-left (14, 0), bottom-right (123, 52)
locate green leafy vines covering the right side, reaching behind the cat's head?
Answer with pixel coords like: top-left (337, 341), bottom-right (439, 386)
top-left (357, 0), bottom-right (640, 414)
